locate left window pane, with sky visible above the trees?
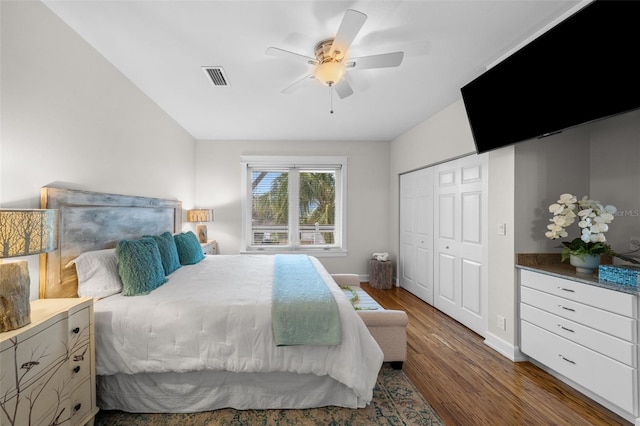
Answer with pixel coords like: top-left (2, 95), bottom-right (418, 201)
top-left (251, 170), bottom-right (289, 245)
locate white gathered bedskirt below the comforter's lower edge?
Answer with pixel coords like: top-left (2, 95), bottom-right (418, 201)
top-left (97, 371), bottom-right (367, 413)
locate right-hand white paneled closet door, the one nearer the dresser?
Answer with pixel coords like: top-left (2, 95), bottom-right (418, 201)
top-left (434, 154), bottom-right (488, 335)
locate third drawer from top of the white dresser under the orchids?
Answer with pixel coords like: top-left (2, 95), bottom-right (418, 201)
top-left (520, 303), bottom-right (638, 367)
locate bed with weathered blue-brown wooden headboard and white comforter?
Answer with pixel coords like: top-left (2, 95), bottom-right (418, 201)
top-left (40, 188), bottom-right (383, 412)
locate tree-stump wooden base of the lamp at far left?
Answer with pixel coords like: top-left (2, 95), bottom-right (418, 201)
top-left (0, 260), bottom-right (31, 333)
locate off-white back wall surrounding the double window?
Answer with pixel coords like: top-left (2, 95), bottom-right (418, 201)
top-left (196, 141), bottom-right (390, 276)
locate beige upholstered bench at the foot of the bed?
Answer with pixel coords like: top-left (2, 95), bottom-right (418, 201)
top-left (332, 274), bottom-right (409, 370)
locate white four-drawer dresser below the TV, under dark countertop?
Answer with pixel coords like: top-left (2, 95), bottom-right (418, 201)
top-left (520, 269), bottom-right (640, 425)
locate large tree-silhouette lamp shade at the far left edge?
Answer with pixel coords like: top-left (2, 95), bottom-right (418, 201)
top-left (0, 209), bottom-right (58, 258)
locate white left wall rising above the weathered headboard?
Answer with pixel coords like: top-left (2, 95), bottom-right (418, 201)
top-left (0, 1), bottom-right (195, 299)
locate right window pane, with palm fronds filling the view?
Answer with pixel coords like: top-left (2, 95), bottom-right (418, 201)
top-left (298, 171), bottom-right (336, 245)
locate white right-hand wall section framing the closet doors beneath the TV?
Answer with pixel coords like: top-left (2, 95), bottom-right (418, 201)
top-left (389, 99), bottom-right (517, 347)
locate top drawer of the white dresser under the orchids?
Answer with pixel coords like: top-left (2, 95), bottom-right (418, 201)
top-left (520, 270), bottom-right (637, 317)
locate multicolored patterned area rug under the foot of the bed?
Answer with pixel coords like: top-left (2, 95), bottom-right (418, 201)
top-left (95, 364), bottom-right (444, 426)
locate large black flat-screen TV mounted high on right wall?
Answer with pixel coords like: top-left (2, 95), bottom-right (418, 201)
top-left (461, 0), bottom-right (640, 153)
